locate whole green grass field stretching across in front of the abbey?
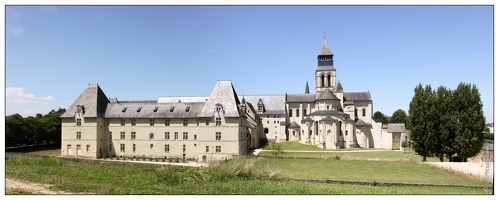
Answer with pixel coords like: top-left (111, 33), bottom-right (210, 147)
top-left (5, 153), bottom-right (492, 194)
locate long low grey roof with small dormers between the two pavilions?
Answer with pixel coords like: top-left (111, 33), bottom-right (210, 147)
top-left (105, 101), bottom-right (205, 119)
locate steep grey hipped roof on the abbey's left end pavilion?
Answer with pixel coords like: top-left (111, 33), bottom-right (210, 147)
top-left (61, 84), bottom-right (109, 118)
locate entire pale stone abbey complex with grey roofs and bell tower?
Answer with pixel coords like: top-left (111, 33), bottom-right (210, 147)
top-left (61, 40), bottom-right (405, 162)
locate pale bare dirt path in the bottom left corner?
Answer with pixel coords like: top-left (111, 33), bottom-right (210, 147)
top-left (5, 178), bottom-right (71, 194)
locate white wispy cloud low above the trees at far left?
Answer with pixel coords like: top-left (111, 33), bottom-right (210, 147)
top-left (5, 87), bottom-right (64, 117)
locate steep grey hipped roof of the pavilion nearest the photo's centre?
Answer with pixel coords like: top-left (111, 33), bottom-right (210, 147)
top-left (199, 81), bottom-right (241, 117)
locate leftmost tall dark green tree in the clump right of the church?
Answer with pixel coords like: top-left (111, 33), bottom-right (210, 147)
top-left (408, 83), bottom-right (433, 162)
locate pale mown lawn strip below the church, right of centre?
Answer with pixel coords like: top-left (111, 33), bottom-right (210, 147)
top-left (255, 159), bottom-right (490, 185)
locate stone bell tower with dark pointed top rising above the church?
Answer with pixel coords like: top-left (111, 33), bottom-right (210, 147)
top-left (315, 38), bottom-right (336, 98)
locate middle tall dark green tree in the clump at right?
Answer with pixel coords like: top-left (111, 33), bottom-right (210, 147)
top-left (430, 86), bottom-right (456, 162)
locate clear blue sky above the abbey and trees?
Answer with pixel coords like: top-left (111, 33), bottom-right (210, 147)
top-left (5, 6), bottom-right (494, 122)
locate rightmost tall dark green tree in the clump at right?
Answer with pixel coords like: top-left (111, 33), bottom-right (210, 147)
top-left (453, 82), bottom-right (485, 162)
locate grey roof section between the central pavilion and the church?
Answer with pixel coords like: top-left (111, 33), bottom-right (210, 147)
top-left (244, 94), bottom-right (286, 115)
